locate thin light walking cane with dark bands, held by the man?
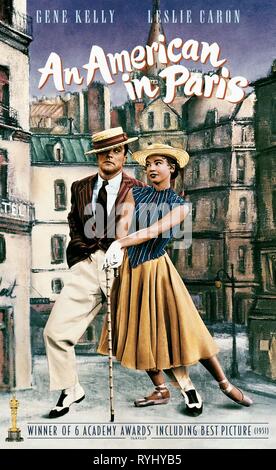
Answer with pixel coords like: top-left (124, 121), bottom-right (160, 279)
top-left (105, 266), bottom-right (118, 423)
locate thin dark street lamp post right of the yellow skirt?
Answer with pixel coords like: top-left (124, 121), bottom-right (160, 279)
top-left (215, 264), bottom-right (240, 378)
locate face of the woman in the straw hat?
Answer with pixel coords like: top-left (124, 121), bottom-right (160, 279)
top-left (146, 155), bottom-right (174, 187)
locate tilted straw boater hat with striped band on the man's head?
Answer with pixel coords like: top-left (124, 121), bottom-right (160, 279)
top-left (85, 127), bottom-right (138, 155)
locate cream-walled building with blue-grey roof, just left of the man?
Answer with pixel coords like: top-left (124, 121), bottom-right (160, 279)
top-left (30, 129), bottom-right (137, 354)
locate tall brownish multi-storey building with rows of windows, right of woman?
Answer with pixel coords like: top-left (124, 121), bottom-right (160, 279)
top-left (180, 92), bottom-right (258, 324)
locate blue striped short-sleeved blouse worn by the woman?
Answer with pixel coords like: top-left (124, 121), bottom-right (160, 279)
top-left (128, 186), bottom-right (186, 268)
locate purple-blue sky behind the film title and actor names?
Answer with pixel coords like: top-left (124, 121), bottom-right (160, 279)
top-left (27, 0), bottom-right (276, 105)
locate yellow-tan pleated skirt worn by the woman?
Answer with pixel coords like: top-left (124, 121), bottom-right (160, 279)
top-left (98, 254), bottom-right (218, 370)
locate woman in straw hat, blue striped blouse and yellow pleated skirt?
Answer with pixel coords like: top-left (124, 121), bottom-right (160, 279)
top-left (98, 144), bottom-right (253, 407)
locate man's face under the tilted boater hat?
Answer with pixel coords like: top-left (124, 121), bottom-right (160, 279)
top-left (98, 145), bottom-right (126, 179)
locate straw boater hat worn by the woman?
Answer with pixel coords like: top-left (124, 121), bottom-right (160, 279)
top-left (131, 144), bottom-right (189, 168)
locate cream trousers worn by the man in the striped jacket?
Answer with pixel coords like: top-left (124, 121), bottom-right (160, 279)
top-left (43, 250), bottom-right (113, 390)
